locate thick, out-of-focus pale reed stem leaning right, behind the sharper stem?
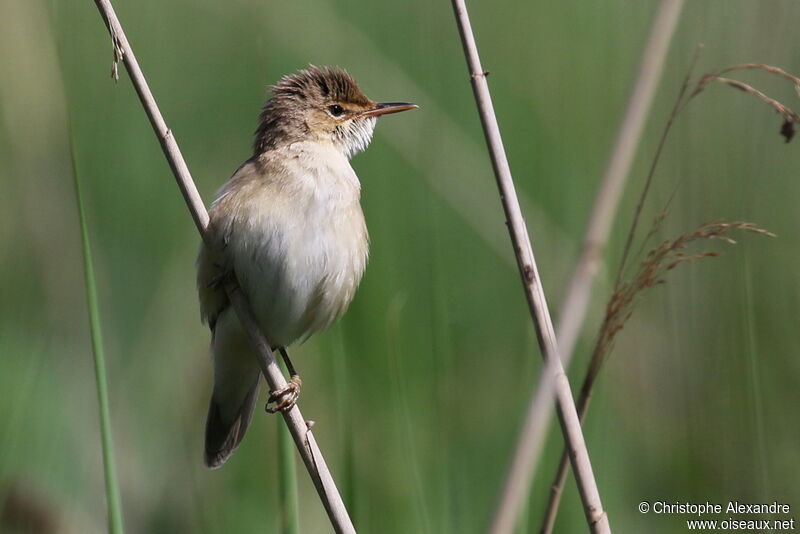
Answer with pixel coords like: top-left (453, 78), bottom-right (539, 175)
top-left (488, 0), bottom-right (684, 524)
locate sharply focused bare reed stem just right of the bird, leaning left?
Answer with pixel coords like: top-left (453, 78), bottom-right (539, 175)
top-left (446, 0), bottom-right (611, 534)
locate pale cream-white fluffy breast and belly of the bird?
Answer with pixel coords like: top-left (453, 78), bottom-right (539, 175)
top-left (229, 152), bottom-right (369, 345)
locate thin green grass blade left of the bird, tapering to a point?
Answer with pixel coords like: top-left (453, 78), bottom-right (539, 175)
top-left (70, 136), bottom-right (124, 534)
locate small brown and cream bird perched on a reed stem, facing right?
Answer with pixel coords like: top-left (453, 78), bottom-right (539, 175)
top-left (197, 65), bottom-right (418, 468)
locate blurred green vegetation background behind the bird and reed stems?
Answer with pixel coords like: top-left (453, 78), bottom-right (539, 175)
top-left (0, 0), bottom-right (800, 534)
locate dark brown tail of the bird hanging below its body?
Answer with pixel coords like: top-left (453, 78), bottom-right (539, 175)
top-left (205, 312), bottom-right (261, 469)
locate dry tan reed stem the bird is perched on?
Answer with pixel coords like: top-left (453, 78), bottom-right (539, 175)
top-left (89, 0), bottom-right (356, 534)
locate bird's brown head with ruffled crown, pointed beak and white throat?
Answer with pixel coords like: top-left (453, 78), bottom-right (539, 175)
top-left (254, 66), bottom-right (417, 158)
